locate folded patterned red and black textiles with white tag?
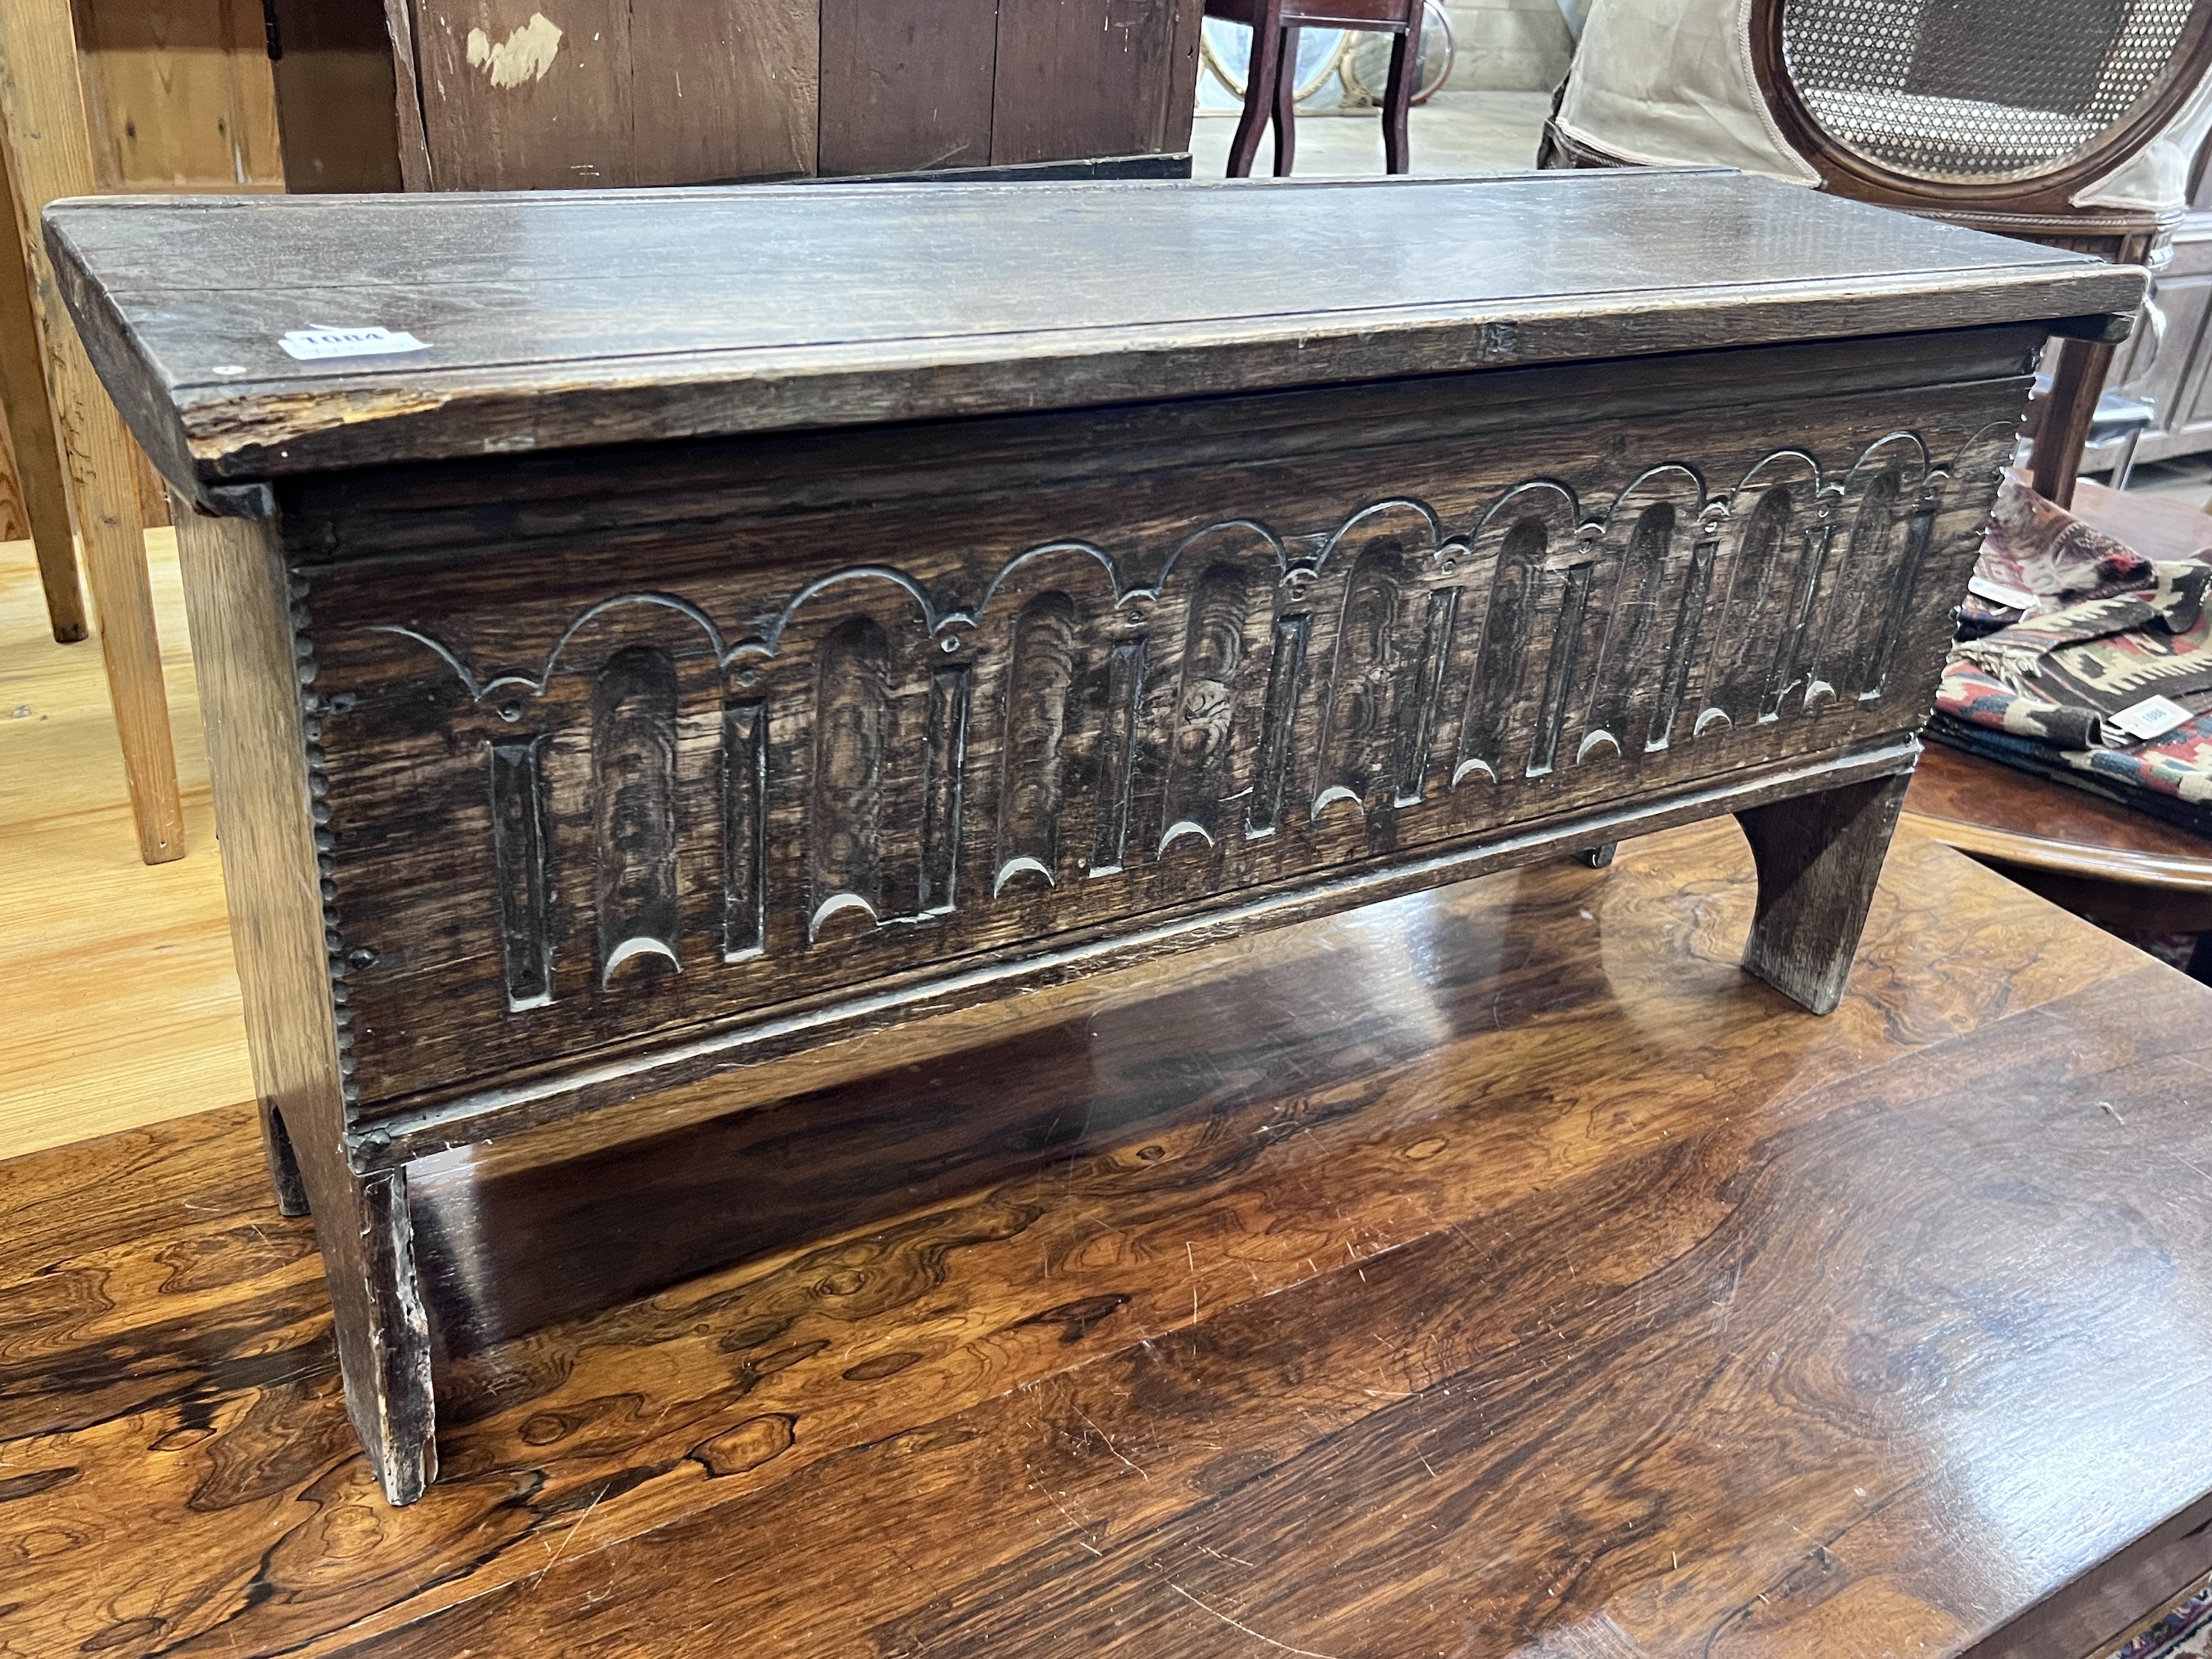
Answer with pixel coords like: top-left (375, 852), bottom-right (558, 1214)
top-left (1929, 480), bottom-right (2212, 836)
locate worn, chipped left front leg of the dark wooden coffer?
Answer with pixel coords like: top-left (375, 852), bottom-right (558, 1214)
top-left (299, 1142), bottom-right (438, 1504)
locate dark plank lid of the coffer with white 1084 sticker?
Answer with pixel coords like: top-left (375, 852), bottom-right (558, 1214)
top-left (47, 168), bottom-right (2146, 502)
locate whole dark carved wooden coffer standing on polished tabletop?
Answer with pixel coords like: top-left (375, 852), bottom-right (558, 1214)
top-left (47, 171), bottom-right (2144, 1502)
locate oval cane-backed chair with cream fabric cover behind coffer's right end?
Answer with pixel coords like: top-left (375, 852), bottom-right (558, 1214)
top-left (1537, 0), bottom-right (2212, 502)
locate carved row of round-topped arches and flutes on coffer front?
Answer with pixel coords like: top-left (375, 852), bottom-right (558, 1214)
top-left (374, 431), bottom-right (2004, 1013)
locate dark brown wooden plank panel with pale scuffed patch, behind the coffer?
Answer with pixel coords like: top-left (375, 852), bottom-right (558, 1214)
top-left (394, 0), bottom-right (1199, 190)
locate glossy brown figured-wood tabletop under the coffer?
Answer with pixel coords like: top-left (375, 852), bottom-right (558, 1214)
top-left (0, 821), bottom-right (2212, 1659)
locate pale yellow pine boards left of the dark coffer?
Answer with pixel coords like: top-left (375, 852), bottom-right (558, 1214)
top-left (0, 529), bottom-right (252, 1159)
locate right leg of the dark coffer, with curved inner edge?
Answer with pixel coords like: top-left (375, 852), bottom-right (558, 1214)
top-left (1737, 774), bottom-right (1911, 1013)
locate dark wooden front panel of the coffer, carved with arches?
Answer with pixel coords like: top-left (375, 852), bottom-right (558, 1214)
top-left (299, 363), bottom-right (2017, 1113)
